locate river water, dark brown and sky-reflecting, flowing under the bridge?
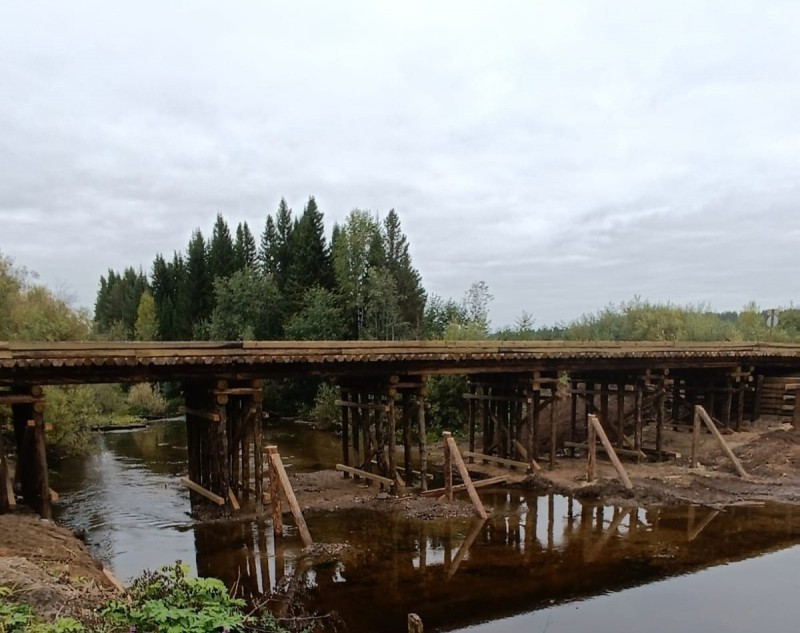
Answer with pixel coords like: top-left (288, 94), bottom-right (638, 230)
top-left (52, 422), bottom-right (800, 633)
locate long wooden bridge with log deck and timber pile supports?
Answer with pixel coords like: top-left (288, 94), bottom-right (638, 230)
top-left (0, 341), bottom-right (800, 516)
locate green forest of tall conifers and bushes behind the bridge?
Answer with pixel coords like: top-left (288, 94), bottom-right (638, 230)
top-left (0, 197), bottom-right (800, 457)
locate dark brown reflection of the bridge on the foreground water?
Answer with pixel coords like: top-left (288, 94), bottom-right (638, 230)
top-left (191, 492), bottom-right (800, 631)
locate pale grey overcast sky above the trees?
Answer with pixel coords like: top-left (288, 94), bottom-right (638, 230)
top-left (0, 0), bottom-right (800, 327)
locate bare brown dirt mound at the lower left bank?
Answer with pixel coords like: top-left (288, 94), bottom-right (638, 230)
top-left (0, 511), bottom-right (118, 621)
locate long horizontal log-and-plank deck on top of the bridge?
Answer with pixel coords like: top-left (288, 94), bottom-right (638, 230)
top-left (0, 341), bottom-right (800, 385)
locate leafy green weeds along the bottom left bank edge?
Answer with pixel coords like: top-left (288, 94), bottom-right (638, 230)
top-left (0, 562), bottom-right (300, 633)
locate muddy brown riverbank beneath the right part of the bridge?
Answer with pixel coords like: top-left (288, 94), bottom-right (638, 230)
top-left (292, 420), bottom-right (800, 519)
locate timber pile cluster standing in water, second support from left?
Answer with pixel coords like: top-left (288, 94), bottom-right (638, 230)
top-left (184, 380), bottom-right (264, 510)
